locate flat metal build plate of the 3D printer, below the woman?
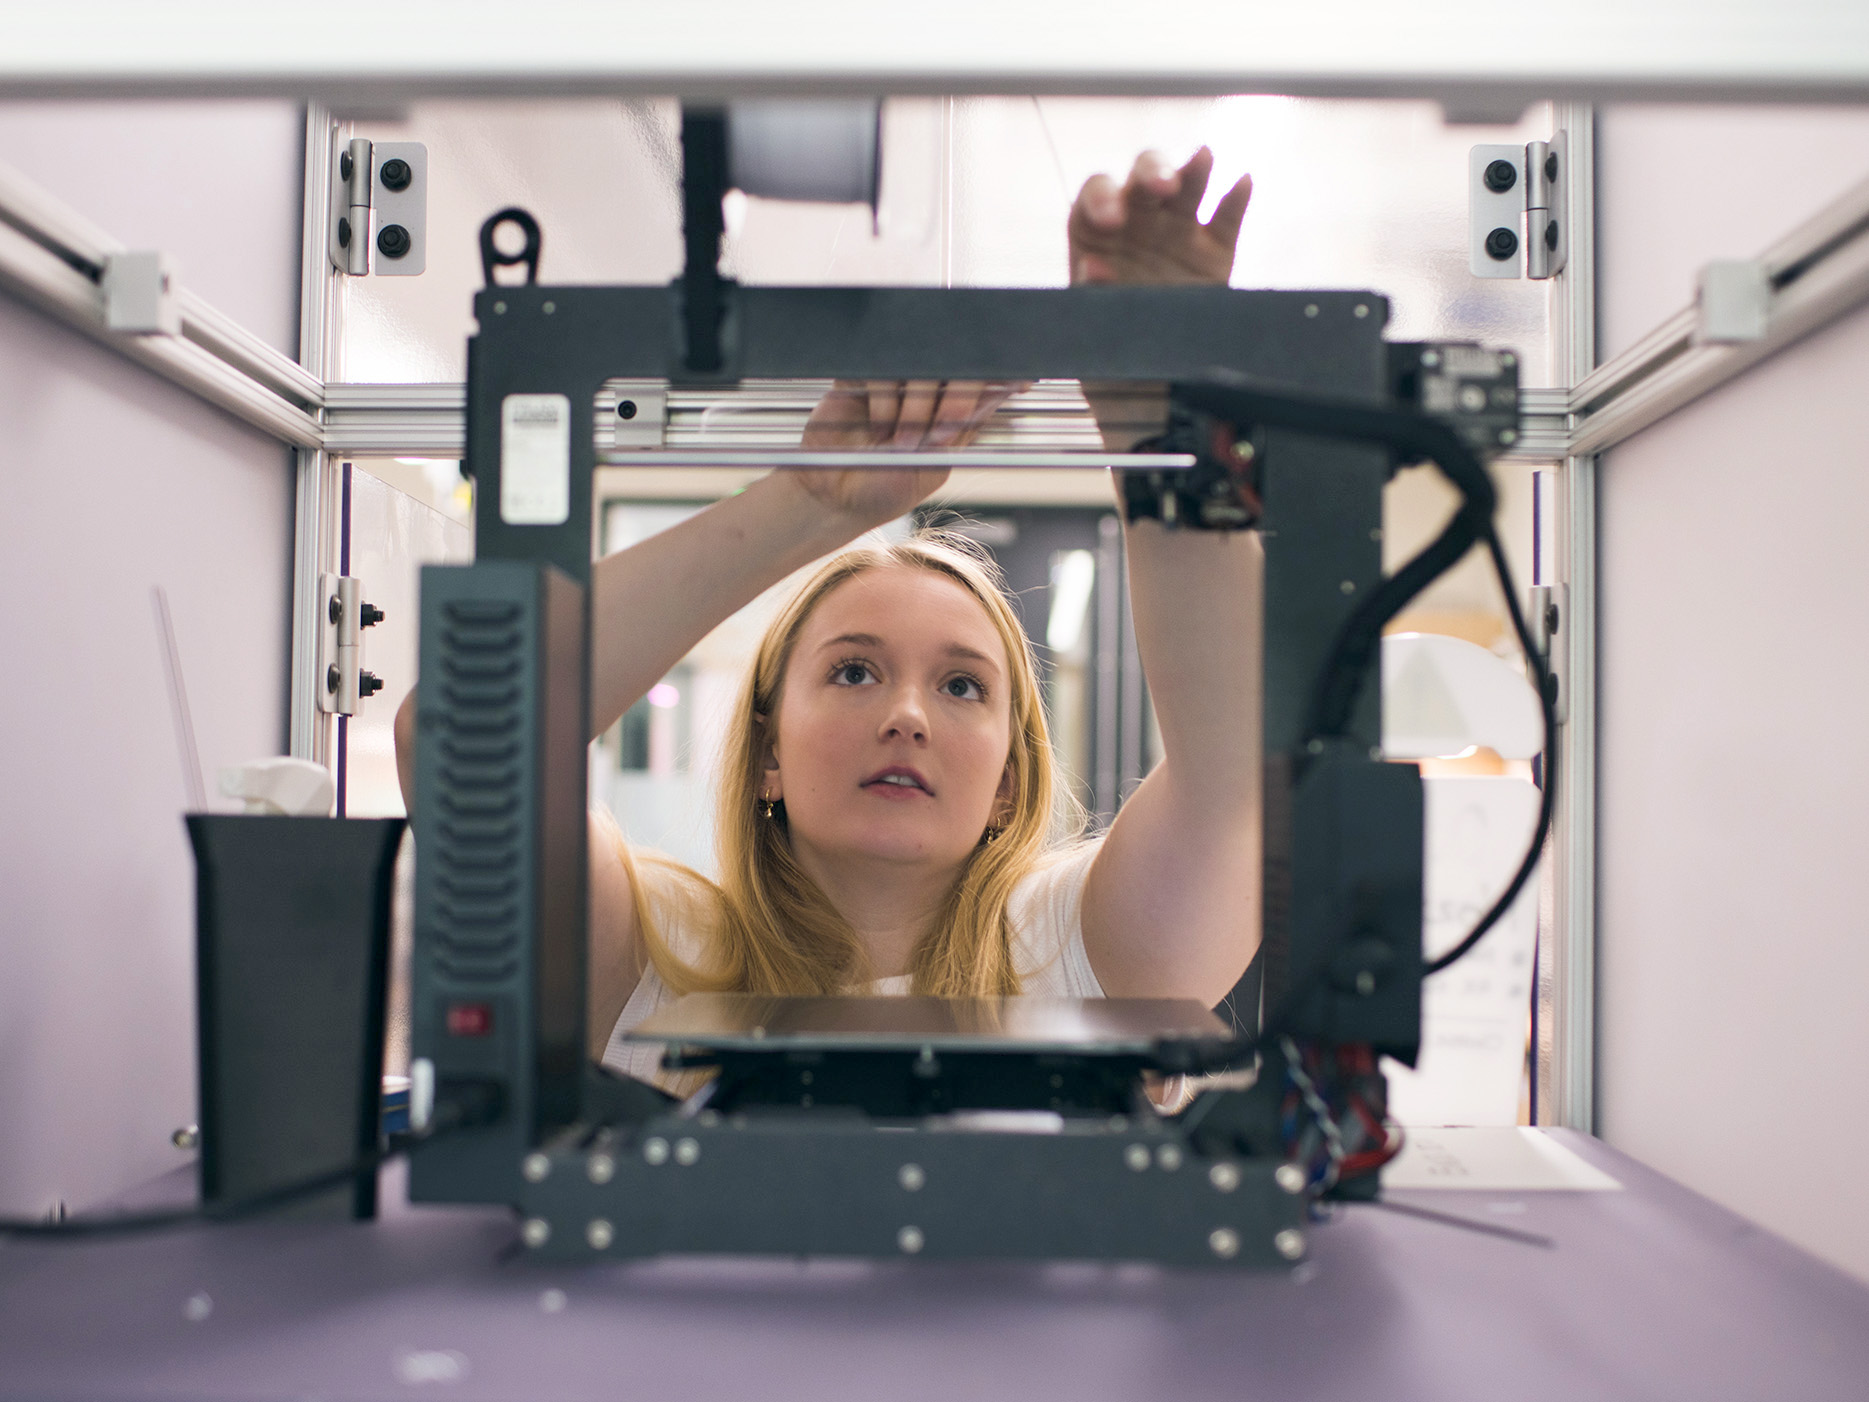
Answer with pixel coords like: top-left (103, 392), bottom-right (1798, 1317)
top-left (624, 993), bottom-right (1230, 1056)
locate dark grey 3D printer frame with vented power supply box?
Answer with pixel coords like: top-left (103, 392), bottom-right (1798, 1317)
top-left (409, 211), bottom-right (1516, 1266)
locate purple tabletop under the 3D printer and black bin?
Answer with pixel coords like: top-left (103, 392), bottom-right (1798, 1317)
top-left (0, 1131), bottom-right (1869, 1402)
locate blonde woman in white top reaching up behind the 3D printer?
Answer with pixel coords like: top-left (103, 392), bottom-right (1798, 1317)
top-left (398, 150), bottom-right (1260, 1077)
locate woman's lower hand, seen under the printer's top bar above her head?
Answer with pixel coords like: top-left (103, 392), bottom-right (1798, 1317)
top-left (789, 379), bottom-right (1024, 525)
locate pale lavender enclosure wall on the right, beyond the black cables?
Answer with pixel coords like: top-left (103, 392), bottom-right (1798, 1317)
top-left (1598, 108), bottom-right (1869, 1279)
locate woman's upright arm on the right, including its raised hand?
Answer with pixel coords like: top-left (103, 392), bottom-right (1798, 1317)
top-left (1071, 150), bottom-right (1263, 1004)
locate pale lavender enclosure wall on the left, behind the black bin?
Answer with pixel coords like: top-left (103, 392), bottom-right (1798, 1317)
top-left (0, 103), bottom-right (303, 1213)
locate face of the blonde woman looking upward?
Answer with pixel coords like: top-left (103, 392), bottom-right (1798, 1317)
top-left (764, 565), bottom-right (1011, 867)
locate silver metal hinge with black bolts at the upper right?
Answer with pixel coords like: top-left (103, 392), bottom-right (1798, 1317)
top-left (1467, 131), bottom-right (1570, 279)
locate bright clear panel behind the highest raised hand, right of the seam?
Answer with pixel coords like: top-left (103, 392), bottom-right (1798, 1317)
top-left (948, 97), bottom-right (1549, 385)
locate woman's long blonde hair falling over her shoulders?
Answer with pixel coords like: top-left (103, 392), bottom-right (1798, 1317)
top-left (622, 531), bottom-right (1071, 996)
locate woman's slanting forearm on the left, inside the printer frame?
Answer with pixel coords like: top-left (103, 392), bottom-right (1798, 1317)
top-left (591, 473), bottom-right (880, 735)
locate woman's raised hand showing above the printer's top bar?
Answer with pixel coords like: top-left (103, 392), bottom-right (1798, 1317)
top-left (1067, 146), bottom-right (1252, 284)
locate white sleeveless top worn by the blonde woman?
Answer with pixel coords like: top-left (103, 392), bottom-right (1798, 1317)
top-left (604, 841), bottom-right (1105, 1080)
